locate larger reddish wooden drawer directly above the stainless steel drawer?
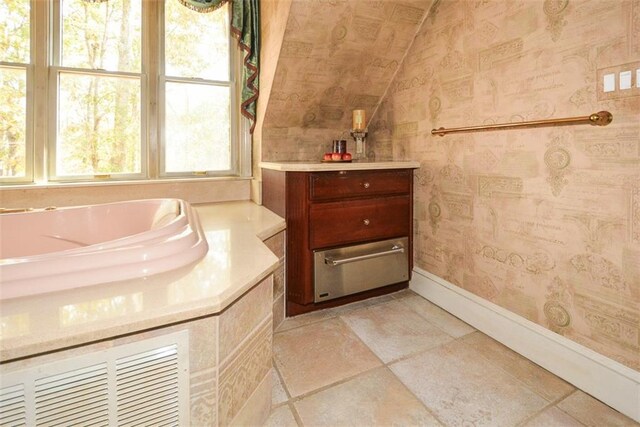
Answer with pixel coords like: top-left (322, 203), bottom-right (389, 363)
top-left (309, 196), bottom-right (411, 249)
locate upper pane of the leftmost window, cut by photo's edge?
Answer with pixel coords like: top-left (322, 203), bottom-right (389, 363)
top-left (0, 0), bottom-right (30, 64)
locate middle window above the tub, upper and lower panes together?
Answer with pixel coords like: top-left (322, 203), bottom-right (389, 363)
top-left (49, 0), bottom-right (145, 179)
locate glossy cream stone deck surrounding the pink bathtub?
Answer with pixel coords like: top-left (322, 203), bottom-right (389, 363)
top-left (0, 200), bottom-right (286, 364)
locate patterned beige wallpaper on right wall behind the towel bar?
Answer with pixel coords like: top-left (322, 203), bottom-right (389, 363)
top-left (370, 0), bottom-right (640, 370)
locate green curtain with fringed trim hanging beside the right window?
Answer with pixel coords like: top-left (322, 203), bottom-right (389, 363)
top-left (178, 0), bottom-right (260, 133)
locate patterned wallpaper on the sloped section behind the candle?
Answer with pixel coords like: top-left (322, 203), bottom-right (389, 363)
top-left (260, 0), bottom-right (432, 160)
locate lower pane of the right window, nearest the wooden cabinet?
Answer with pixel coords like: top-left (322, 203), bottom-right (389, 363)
top-left (165, 83), bottom-right (231, 172)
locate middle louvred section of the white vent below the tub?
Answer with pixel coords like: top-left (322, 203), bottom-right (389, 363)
top-left (35, 363), bottom-right (109, 426)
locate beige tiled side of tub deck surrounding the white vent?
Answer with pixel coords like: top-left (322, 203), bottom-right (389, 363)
top-left (0, 276), bottom-right (273, 426)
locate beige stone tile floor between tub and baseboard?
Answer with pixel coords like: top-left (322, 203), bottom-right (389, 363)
top-left (267, 290), bottom-right (638, 427)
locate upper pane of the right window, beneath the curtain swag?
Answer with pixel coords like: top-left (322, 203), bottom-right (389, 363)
top-left (164, 0), bottom-right (229, 81)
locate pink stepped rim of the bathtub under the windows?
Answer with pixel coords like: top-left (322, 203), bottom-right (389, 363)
top-left (0, 198), bottom-right (209, 303)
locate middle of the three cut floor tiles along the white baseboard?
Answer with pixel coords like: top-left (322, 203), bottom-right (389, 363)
top-left (462, 332), bottom-right (575, 401)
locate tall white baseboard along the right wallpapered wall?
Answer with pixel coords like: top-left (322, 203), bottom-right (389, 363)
top-left (409, 267), bottom-right (640, 422)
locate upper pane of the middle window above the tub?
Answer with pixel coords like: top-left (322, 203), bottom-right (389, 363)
top-left (61, 0), bottom-right (142, 72)
